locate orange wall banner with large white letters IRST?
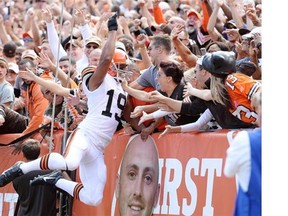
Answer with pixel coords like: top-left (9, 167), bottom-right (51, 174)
top-left (0, 130), bottom-right (236, 216)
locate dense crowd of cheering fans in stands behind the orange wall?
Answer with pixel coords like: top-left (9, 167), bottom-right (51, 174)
top-left (0, 0), bottom-right (262, 139)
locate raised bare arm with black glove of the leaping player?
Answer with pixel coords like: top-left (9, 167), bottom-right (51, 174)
top-left (88, 14), bottom-right (118, 91)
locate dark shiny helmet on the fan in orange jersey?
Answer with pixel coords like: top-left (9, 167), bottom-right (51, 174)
top-left (202, 51), bottom-right (236, 78)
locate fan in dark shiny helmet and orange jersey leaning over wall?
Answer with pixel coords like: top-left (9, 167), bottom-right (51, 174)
top-left (178, 51), bottom-right (261, 125)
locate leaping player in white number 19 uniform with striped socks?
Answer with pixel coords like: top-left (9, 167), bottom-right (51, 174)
top-left (0, 15), bottom-right (126, 206)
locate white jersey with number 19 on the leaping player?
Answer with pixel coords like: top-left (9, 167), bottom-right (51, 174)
top-left (78, 74), bottom-right (127, 148)
